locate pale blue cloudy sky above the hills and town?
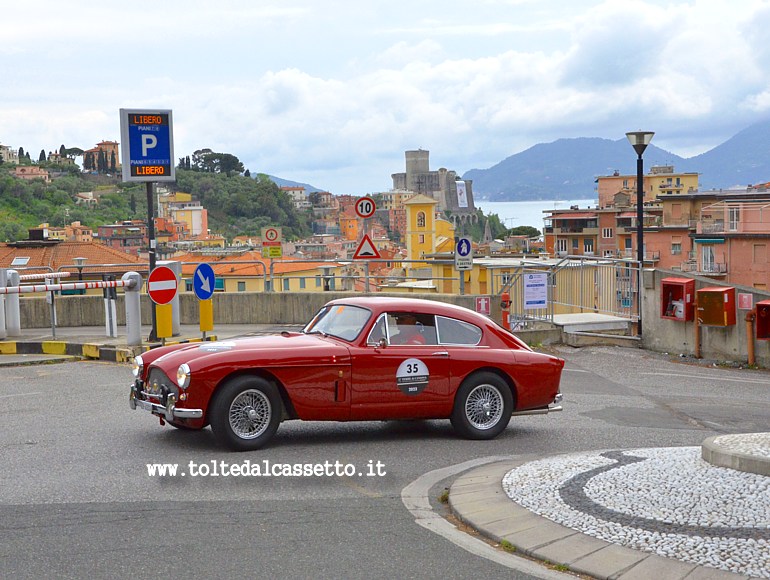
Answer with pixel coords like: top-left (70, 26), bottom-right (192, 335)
top-left (0, 0), bottom-right (770, 197)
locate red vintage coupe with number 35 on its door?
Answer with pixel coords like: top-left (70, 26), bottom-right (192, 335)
top-left (130, 296), bottom-right (564, 451)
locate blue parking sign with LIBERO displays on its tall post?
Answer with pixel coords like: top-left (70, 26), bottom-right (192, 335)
top-left (120, 109), bottom-right (176, 340)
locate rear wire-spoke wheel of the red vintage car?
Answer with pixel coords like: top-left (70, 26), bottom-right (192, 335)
top-left (451, 372), bottom-right (513, 439)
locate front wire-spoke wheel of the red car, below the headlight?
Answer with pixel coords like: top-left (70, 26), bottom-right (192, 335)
top-left (209, 377), bottom-right (283, 451)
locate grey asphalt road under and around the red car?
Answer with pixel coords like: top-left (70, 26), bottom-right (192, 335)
top-left (0, 347), bottom-right (770, 578)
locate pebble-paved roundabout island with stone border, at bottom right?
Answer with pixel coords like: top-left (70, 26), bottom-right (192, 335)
top-left (449, 440), bottom-right (770, 580)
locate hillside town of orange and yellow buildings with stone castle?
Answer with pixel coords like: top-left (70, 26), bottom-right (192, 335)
top-left (0, 141), bottom-right (770, 294)
